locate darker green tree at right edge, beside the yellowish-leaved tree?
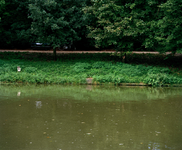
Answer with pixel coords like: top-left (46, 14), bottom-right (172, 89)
top-left (147, 0), bottom-right (182, 54)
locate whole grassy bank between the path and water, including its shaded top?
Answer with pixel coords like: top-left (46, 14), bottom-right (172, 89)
top-left (0, 52), bottom-right (182, 86)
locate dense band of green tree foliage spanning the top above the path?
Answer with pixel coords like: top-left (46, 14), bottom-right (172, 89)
top-left (0, 0), bottom-right (182, 53)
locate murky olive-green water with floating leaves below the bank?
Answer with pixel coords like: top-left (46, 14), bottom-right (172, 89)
top-left (0, 85), bottom-right (182, 150)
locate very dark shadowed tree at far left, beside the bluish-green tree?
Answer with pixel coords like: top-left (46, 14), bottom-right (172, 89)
top-left (0, 0), bottom-right (31, 48)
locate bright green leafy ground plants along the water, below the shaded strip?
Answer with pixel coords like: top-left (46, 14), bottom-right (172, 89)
top-left (0, 54), bottom-right (182, 86)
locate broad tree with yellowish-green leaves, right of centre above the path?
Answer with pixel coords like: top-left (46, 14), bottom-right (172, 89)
top-left (84, 0), bottom-right (156, 51)
